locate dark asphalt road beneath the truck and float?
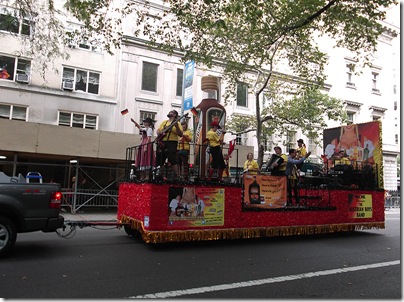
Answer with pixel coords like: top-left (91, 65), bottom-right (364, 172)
top-left (0, 211), bottom-right (402, 299)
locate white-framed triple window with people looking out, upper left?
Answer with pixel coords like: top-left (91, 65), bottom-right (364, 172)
top-left (62, 67), bottom-right (100, 94)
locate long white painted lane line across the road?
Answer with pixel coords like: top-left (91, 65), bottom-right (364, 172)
top-left (128, 260), bottom-right (400, 299)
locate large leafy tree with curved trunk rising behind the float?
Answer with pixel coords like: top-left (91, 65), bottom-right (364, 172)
top-left (8, 0), bottom-right (397, 164)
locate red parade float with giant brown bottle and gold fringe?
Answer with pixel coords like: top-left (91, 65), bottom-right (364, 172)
top-left (117, 77), bottom-right (385, 243)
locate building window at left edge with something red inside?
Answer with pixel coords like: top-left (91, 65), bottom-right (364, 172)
top-left (0, 56), bottom-right (31, 82)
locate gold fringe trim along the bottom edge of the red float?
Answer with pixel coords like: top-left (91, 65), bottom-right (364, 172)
top-left (120, 216), bottom-right (385, 243)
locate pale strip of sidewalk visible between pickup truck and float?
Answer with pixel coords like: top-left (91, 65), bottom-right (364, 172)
top-left (60, 208), bottom-right (117, 221)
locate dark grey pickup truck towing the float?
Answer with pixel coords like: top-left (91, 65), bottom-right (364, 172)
top-left (0, 172), bottom-right (64, 258)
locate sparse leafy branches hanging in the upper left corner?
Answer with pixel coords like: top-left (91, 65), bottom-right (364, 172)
top-left (0, 0), bottom-right (133, 79)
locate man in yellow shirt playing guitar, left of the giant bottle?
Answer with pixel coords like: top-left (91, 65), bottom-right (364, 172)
top-left (156, 110), bottom-right (183, 176)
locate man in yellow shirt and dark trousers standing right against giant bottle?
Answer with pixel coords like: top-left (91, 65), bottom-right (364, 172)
top-left (204, 121), bottom-right (226, 181)
